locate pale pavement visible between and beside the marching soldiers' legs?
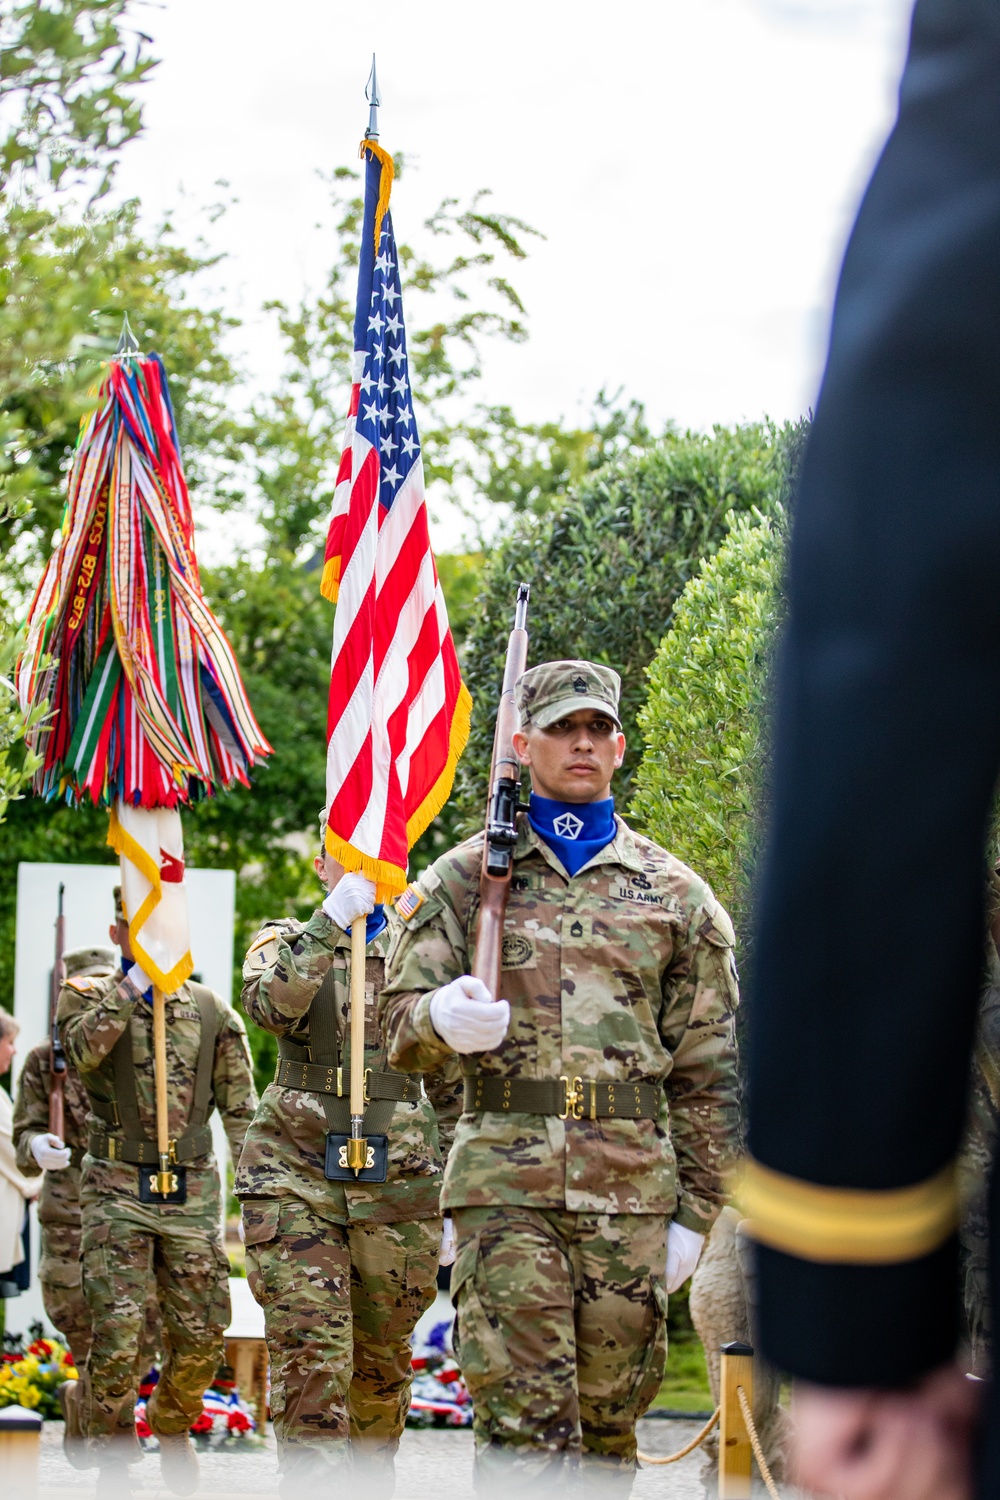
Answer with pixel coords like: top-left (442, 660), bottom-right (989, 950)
top-left (39, 1421), bottom-right (763, 1500)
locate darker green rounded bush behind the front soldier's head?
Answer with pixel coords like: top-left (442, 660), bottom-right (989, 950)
top-left (440, 423), bottom-right (795, 869)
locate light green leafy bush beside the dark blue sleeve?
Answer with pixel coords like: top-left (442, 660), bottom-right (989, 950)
top-left (630, 509), bottom-right (786, 939)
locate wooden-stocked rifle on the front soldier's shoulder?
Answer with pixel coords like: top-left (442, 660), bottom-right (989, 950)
top-left (472, 584), bottom-right (529, 1001)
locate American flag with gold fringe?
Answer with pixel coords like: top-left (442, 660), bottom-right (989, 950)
top-left (322, 141), bottom-right (472, 900)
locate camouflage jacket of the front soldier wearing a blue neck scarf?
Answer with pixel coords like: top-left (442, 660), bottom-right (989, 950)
top-left (381, 816), bottom-right (738, 1232)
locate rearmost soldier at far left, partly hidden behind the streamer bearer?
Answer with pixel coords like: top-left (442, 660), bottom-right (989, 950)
top-left (13, 947), bottom-right (159, 1376)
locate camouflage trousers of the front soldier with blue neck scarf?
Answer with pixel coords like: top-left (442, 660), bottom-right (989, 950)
top-left (451, 1205), bottom-right (667, 1493)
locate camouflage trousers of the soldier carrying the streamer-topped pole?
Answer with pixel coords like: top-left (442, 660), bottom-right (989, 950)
top-left (72, 1199), bottom-right (231, 1449)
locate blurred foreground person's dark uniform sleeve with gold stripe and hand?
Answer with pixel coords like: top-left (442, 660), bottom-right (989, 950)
top-left (745, 0), bottom-right (1000, 1500)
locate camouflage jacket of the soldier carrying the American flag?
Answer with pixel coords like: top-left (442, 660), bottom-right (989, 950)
top-left (235, 908), bottom-right (462, 1224)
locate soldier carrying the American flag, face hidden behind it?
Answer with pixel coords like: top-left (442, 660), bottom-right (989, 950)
top-left (237, 822), bottom-right (460, 1496)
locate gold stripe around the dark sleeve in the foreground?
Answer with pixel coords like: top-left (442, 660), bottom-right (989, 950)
top-left (735, 1161), bottom-right (958, 1266)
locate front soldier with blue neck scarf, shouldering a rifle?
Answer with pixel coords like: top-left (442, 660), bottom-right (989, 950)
top-left (381, 662), bottom-right (738, 1493)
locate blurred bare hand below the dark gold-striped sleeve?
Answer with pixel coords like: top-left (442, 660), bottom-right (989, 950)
top-left (790, 1365), bottom-right (982, 1500)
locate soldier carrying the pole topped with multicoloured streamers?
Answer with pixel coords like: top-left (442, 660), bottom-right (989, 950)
top-left (58, 890), bottom-right (256, 1494)
